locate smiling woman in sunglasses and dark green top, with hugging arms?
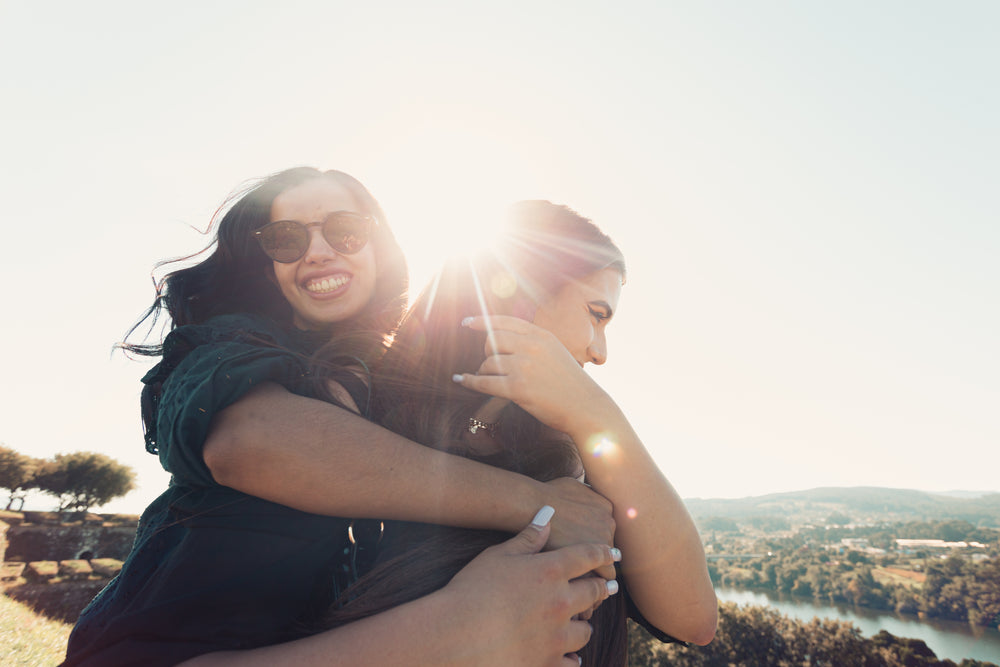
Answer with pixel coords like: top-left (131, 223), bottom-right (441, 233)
top-left (65, 168), bottom-right (614, 665)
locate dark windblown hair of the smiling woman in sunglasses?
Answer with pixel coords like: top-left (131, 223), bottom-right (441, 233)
top-left (118, 167), bottom-right (408, 453)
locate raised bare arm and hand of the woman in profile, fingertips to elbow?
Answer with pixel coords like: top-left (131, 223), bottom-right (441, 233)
top-left (454, 316), bottom-right (718, 644)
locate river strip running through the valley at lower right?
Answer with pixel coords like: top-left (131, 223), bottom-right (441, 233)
top-left (715, 588), bottom-right (1000, 664)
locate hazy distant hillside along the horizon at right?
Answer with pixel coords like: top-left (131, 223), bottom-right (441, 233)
top-left (684, 486), bottom-right (1000, 528)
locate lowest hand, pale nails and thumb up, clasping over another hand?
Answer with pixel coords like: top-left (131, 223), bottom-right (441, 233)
top-left (441, 512), bottom-right (617, 667)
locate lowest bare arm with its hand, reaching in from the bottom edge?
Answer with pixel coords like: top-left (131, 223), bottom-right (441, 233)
top-left (183, 508), bottom-right (612, 667)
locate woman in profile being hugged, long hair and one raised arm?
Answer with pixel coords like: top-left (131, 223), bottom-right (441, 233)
top-left (327, 201), bottom-right (717, 667)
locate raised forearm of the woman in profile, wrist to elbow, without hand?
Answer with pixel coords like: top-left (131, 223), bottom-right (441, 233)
top-left (570, 398), bottom-right (718, 644)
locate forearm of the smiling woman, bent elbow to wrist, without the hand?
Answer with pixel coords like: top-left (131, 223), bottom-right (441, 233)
top-left (204, 384), bottom-right (547, 532)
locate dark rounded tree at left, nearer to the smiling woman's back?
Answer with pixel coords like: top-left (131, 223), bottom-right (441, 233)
top-left (33, 452), bottom-right (135, 512)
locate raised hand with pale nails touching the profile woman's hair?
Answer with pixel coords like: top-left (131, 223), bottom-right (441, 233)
top-left (455, 315), bottom-right (614, 435)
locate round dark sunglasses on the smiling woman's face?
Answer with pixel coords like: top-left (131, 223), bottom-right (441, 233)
top-left (253, 211), bottom-right (374, 264)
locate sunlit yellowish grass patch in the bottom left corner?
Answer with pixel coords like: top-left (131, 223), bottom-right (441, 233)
top-left (0, 594), bottom-right (73, 667)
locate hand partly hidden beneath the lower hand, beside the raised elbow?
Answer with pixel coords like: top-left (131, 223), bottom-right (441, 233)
top-left (543, 477), bottom-right (615, 579)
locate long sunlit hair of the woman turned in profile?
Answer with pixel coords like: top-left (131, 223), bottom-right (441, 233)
top-left (323, 201), bottom-right (627, 667)
